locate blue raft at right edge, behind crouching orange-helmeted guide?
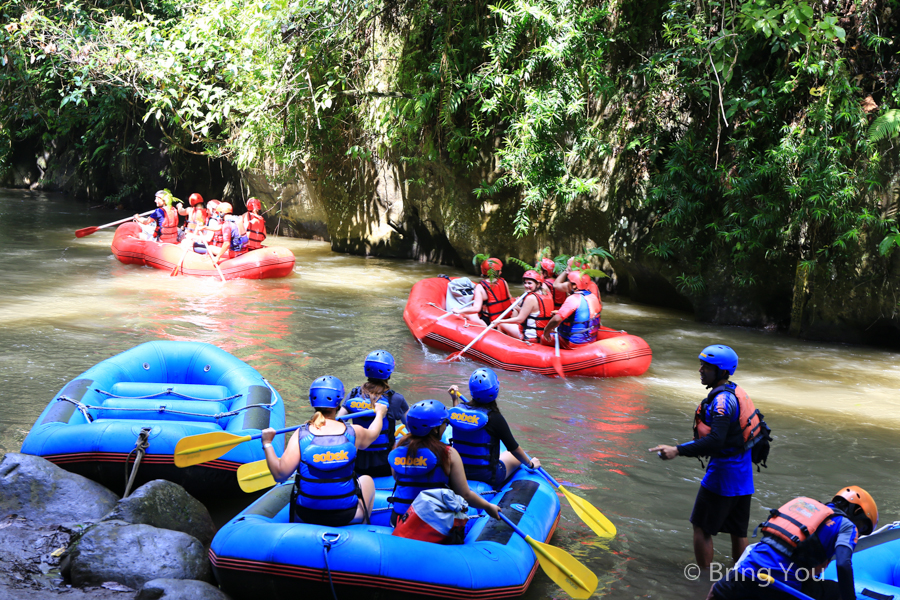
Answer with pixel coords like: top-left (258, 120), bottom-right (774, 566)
top-left (825, 521), bottom-right (900, 600)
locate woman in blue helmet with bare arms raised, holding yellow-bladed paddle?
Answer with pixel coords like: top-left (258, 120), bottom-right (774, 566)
top-left (262, 375), bottom-right (387, 527)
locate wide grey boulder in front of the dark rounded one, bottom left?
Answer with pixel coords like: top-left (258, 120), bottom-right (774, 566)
top-left (69, 521), bottom-right (210, 589)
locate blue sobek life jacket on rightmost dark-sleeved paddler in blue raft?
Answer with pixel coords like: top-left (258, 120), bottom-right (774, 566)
top-left (449, 405), bottom-right (500, 485)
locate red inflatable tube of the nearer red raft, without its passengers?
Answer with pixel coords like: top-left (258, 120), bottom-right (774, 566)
top-left (403, 277), bottom-right (653, 377)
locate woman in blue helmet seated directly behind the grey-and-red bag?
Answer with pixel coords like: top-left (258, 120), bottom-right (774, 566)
top-left (388, 400), bottom-right (500, 525)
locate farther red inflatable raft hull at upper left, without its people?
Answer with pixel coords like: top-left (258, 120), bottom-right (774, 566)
top-left (112, 223), bottom-right (294, 279)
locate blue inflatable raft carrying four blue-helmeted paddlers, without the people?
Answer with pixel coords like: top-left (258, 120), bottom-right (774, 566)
top-left (209, 469), bottom-right (559, 600)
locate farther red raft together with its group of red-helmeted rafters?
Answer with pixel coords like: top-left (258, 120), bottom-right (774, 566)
top-left (112, 190), bottom-right (295, 281)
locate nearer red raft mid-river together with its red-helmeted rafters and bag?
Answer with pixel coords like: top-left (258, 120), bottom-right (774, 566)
top-left (403, 258), bottom-right (652, 377)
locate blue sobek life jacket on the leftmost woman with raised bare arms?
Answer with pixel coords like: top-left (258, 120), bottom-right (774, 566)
top-left (293, 425), bottom-right (359, 510)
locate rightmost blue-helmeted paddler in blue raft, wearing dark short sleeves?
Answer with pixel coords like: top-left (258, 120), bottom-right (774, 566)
top-left (449, 367), bottom-right (541, 490)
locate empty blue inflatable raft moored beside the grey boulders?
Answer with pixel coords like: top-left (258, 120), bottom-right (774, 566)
top-left (22, 341), bottom-right (285, 499)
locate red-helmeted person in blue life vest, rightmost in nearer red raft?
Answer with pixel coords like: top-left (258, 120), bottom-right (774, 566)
top-left (541, 271), bottom-right (601, 348)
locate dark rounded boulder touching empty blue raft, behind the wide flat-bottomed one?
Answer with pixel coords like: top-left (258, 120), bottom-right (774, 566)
top-left (102, 479), bottom-right (216, 545)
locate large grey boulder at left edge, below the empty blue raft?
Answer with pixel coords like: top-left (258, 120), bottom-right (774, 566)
top-left (0, 452), bottom-right (119, 525)
